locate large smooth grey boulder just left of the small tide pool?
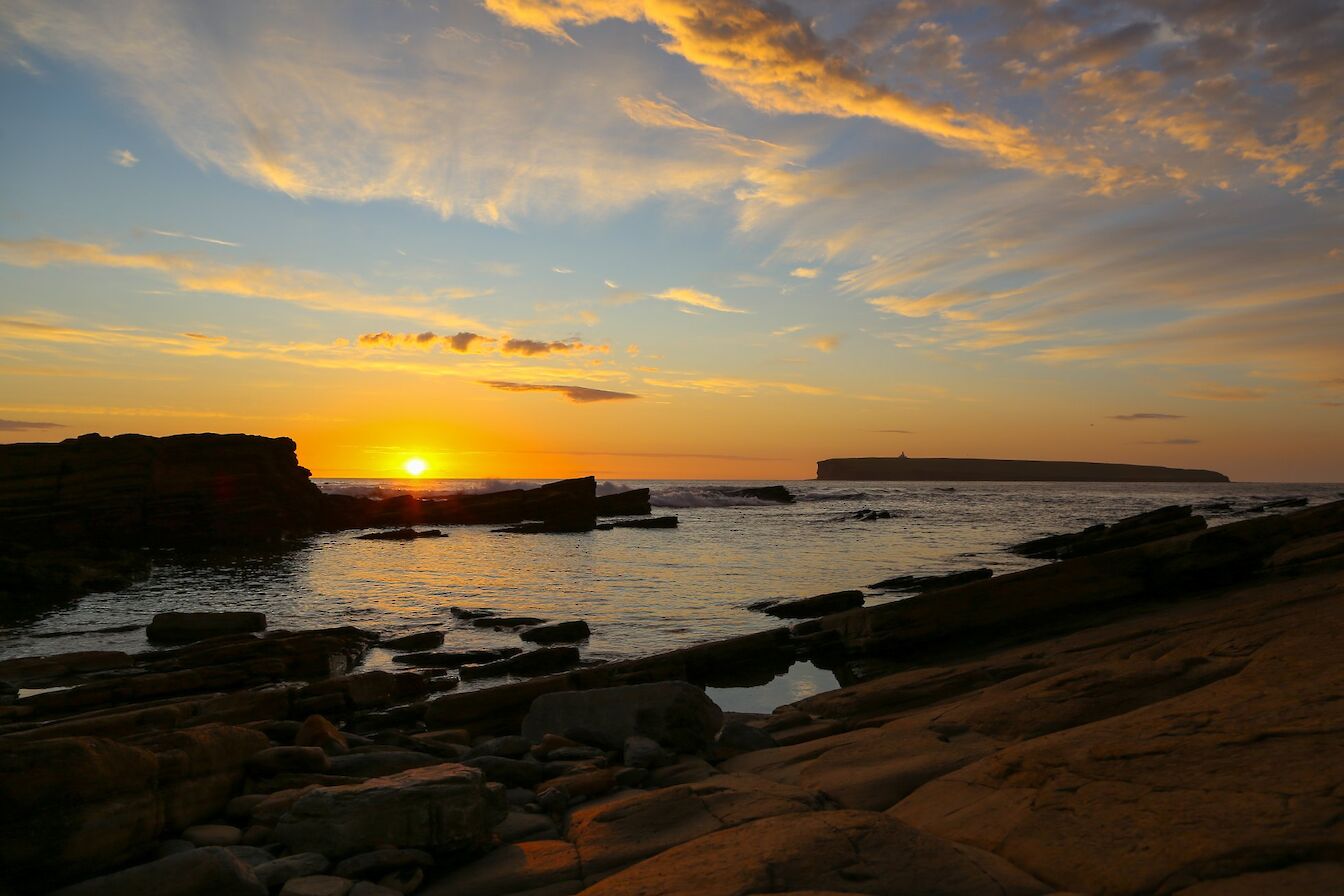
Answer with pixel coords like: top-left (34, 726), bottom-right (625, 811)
top-left (523, 681), bottom-right (723, 754)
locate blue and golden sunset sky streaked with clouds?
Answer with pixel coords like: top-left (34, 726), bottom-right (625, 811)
top-left (0, 0), bottom-right (1344, 481)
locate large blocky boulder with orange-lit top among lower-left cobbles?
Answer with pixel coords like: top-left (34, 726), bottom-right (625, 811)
top-left (276, 764), bottom-right (504, 857)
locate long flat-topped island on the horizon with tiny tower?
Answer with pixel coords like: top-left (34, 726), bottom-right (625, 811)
top-left (817, 454), bottom-right (1231, 482)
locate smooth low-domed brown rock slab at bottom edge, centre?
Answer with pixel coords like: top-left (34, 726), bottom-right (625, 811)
top-left (583, 810), bottom-right (1052, 896)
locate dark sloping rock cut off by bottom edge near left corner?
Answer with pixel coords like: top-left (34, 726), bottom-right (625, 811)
top-left (52, 846), bottom-right (266, 896)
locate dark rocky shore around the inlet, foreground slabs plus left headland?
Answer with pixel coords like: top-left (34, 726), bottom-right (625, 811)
top-left (0, 435), bottom-right (1344, 896)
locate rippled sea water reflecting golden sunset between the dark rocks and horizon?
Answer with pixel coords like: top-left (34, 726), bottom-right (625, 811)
top-left (0, 480), bottom-right (1344, 703)
